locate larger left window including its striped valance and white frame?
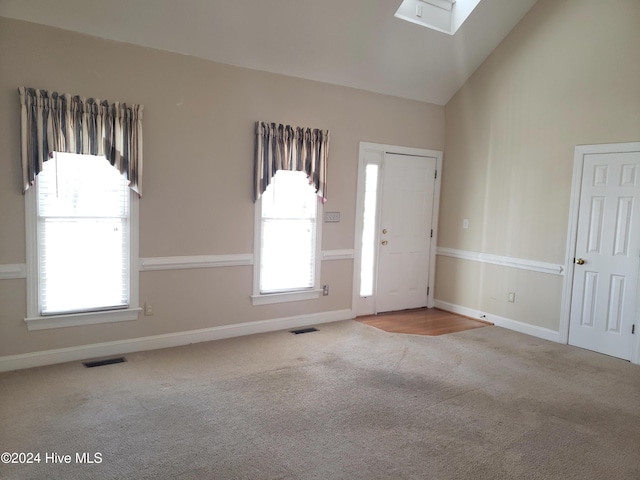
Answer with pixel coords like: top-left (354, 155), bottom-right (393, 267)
top-left (19, 87), bottom-right (143, 330)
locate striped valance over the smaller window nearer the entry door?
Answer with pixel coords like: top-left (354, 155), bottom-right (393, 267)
top-left (254, 122), bottom-right (329, 201)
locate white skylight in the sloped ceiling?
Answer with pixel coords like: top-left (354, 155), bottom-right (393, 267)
top-left (395, 0), bottom-right (481, 35)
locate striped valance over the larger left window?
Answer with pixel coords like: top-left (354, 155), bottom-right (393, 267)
top-left (18, 87), bottom-right (144, 196)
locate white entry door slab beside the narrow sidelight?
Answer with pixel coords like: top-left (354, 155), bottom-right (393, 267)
top-left (375, 153), bottom-right (436, 312)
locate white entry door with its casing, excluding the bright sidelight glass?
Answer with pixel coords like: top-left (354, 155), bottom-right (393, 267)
top-left (352, 142), bottom-right (442, 315)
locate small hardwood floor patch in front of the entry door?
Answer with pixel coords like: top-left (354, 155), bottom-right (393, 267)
top-left (356, 308), bottom-right (493, 336)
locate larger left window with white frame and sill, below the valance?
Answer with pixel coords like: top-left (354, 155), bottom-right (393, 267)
top-left (26, 153), bottom-right (139, 329)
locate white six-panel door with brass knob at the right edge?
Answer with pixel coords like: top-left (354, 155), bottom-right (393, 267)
top-left (569, 152), bottom-right (640, 360)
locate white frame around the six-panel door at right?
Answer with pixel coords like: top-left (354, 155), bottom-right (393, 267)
top-left (559, 142), bottom-right (640, 365)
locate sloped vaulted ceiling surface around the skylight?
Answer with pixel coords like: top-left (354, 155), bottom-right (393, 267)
top-left (0, 0), bottom-right (536, 105)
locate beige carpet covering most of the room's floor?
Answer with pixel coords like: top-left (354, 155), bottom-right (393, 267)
top-left (0, 321), bottom-right (640, 480)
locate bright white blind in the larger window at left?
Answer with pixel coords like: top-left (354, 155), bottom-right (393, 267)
top-left (37, 153), bottom-right (130, 315)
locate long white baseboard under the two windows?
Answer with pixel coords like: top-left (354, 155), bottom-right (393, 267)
top-left (0, 310), bottom-right (355, 372)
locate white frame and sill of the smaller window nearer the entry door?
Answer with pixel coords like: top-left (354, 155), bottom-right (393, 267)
top-left (251, 172), bottom-right (323, 305)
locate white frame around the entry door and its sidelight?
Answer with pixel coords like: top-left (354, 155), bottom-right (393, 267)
top-left (351, 142), bottom-right (442, 315)
